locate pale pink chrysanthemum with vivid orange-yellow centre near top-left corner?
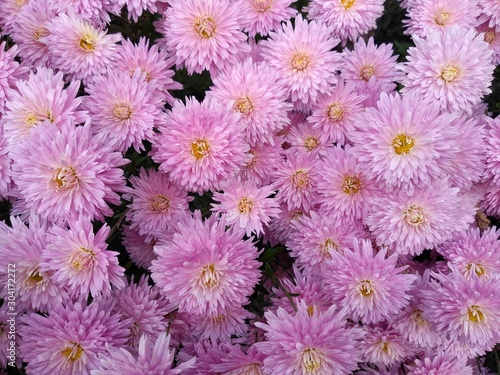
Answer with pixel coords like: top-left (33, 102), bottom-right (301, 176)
top-left (40, 13), bottom-right (121, 82)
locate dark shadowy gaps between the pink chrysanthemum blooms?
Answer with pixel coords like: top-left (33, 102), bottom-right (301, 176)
top-left (0, 0), bottom-right (500, 375)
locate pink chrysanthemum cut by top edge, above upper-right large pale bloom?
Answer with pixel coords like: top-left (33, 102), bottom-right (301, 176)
top-left (403, 0), bottom-right (481, 37)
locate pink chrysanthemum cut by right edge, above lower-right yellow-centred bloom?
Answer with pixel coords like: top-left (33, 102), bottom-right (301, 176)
top-left (437, 227), bottom-right (500, 279)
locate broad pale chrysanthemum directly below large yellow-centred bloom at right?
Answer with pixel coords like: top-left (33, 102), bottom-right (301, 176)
top-left (366, 180), bottom-right (476, 255)
